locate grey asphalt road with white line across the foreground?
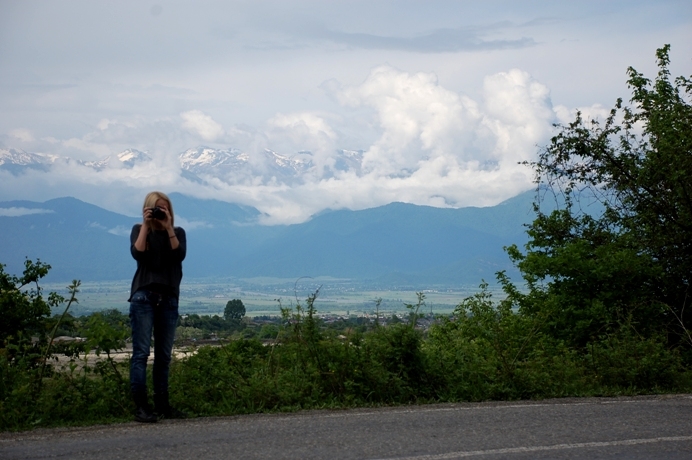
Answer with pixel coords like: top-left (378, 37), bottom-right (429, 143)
top-left (0, 395), bottom-right (692, 460)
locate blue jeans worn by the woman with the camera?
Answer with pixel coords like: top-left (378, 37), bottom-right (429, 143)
top-left (130, 289), bottom-right (178, 395)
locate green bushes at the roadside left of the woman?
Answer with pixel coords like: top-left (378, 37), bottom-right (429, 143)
top-left (0, 260), bottom-right (136, 429)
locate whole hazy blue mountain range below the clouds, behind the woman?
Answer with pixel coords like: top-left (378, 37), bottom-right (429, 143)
top-left (0, 192), bottom-right (533, 285)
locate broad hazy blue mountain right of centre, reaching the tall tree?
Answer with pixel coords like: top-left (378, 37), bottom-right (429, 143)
top-left (241, 194), bottom-right (533, 284)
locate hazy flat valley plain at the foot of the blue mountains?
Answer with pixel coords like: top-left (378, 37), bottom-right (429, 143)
top-left (43, 277), bottom-right (501, 317)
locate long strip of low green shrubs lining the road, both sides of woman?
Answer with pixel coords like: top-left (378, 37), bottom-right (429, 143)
top-left (5, 294), bottom-right (692, 431)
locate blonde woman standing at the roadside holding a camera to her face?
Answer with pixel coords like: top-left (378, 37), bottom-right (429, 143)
top-left (129, 192), bottom-right (186, 422)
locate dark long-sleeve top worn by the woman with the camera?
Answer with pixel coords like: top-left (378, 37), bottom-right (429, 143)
top-left (128, 224), bottom-right (187, 302)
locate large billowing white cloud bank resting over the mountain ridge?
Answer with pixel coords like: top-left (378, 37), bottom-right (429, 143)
top-left (138, 66), bottom-right (556, 224)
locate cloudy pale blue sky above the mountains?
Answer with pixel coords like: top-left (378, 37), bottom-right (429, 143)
top-left (0, 0), bottom-right (692, 224)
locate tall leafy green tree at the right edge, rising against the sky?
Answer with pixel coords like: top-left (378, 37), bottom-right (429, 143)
top-left (508, 45), bottom-right (692, 345)
